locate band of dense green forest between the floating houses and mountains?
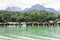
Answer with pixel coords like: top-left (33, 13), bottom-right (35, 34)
top-left (0, 11), bottom-right (60, 22)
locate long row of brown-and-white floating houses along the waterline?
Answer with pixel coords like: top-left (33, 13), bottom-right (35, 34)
top-left (0, 21), bottom-right (60, 26)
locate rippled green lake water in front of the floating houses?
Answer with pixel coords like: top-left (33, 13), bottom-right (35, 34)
top-left (0, 26), bottom-right (60, 40)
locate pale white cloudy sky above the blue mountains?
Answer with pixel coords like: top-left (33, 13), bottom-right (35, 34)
top-left (0, 0), bottom-right (60, 10)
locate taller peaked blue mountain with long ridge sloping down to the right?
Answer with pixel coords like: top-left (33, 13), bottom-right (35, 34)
top-left (24, 4), bottom-right (58, 13)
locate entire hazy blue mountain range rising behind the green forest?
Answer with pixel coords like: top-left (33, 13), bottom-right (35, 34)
top-left (6, 4), bottom-right (59, 13)
